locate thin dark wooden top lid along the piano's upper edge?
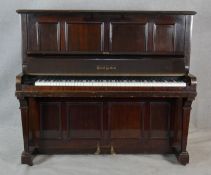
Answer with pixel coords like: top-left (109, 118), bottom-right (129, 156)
top-left (16, 9), bottom-right (197, 15)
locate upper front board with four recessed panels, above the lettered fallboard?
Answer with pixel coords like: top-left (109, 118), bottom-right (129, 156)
top-left (27, 14), bottom-right (185, 55)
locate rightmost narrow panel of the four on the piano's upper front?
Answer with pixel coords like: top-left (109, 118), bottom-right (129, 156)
top-left (152, 15), bottom-right (185, 54)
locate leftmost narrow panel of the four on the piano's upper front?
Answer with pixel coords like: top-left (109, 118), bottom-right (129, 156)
top-left (28, 15), bottom-right (61, 52)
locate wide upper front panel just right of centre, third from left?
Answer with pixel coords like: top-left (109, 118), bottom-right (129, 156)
top-left (109, 22), bottom-right (148, 52)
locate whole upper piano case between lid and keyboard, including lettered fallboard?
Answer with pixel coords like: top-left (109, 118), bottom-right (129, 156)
top-left (21, 12), bottom-right (192, 76)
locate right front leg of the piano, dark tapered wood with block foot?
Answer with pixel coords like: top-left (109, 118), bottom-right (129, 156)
top-left (177, 98), bottom-right (193, 165)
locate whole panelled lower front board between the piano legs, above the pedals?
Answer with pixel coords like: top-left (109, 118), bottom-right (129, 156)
top-left (29, 98), bottom-right (180, 153)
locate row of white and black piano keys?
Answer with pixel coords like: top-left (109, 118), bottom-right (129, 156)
top-left (35, 78), bottom-right (186, 87)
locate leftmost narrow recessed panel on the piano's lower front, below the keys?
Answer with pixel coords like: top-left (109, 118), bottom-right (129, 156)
top-left (40, 102), bottom-right (61, 139)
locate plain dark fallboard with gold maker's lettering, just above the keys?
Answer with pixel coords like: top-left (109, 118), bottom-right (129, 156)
top-left (24, 57), bottom-right (185, 76)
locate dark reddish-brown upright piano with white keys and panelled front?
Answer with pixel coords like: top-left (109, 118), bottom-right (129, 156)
top-left (16, 10), bottom-right (197, 165)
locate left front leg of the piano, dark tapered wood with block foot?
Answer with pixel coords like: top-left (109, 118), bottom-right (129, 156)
top-left (19, 97), bottom-right (33, 166)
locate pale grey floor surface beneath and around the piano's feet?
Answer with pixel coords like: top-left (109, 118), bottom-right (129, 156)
top-left (0, 127), bottom-right (211, 175)
